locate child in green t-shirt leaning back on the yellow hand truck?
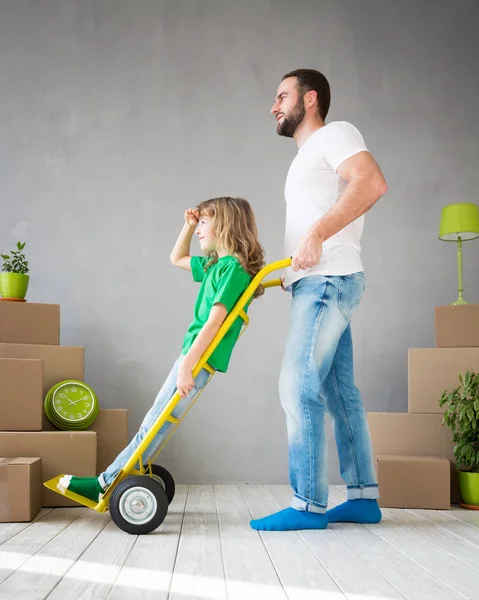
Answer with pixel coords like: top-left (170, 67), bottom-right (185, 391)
top-left (60, 197), bottom-right (265, 502)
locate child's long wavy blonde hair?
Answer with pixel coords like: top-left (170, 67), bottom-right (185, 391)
top-left (196, 196), bottom-right (265, 298)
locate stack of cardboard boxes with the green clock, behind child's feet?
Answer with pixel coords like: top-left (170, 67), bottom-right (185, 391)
top-left (0, 301), bottom-right (128, 522)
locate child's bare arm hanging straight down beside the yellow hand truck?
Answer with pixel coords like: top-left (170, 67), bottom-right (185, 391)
top-left (176, 303), bottom-right (228, 397)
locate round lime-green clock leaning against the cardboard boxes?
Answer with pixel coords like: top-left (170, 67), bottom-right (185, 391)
top-left (44, 379), bottom-right (99, 430)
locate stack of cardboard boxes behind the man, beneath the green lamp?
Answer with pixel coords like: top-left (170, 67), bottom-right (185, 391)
top-left (368, 304), bottom-right (479, 509)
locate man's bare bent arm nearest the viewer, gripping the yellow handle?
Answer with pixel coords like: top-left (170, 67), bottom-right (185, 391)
top-left (292, 151), bottom-right (387, 271)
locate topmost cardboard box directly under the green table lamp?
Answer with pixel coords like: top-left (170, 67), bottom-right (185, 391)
top-left (435, 304), bottom-right (479, 348)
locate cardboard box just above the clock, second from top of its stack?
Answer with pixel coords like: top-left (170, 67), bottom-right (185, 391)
top-left (0, 342), bottom-right (85, 398)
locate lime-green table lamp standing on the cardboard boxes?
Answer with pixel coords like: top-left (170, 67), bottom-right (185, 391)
top-left (439, 204), bottom-right (479, 305)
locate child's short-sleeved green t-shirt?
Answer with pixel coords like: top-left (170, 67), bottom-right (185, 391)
top-left (181, 256), bottom-right (251, 373)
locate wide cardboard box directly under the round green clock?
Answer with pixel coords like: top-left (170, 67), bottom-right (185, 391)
top-left (0, 431), bottom-right (96, 506)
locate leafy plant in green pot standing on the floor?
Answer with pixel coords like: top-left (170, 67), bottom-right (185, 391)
top-left (439, 369), bottom-right (479, 509)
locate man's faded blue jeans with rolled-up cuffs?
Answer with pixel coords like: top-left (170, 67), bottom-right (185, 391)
top-left (280, 272), bottom-right (379, 512)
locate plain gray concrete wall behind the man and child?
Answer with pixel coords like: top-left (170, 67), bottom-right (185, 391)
top-left (0, 0), bottom-right (479, 482)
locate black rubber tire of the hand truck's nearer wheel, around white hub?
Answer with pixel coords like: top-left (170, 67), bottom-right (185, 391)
top-left (109, 475), bottom-right (168, 535)
